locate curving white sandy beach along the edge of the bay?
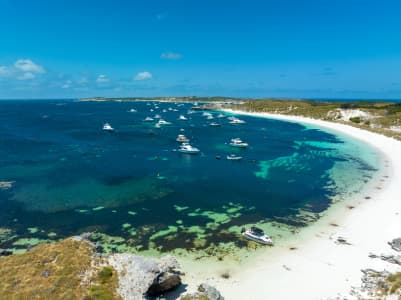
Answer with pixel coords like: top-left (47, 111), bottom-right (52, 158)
top-left (185, 111), bottom-right (401, 300)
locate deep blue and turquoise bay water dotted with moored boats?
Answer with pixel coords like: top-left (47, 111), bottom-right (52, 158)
top-left (0, 101), bottom-right (379, 252)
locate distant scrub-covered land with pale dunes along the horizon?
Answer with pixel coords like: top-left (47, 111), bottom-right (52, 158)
top-left (79, 96), bottom-right (401, 140)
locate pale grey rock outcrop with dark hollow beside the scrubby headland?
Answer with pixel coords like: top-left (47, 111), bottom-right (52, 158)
top-left (109, 254), bottom-right (182, 300)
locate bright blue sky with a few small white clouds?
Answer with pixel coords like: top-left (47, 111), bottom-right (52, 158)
top-left (0, 0), bottom-right (401, 99)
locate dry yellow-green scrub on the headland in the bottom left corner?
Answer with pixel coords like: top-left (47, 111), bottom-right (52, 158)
top-left (0, 238), bottom-right (120, 300)
